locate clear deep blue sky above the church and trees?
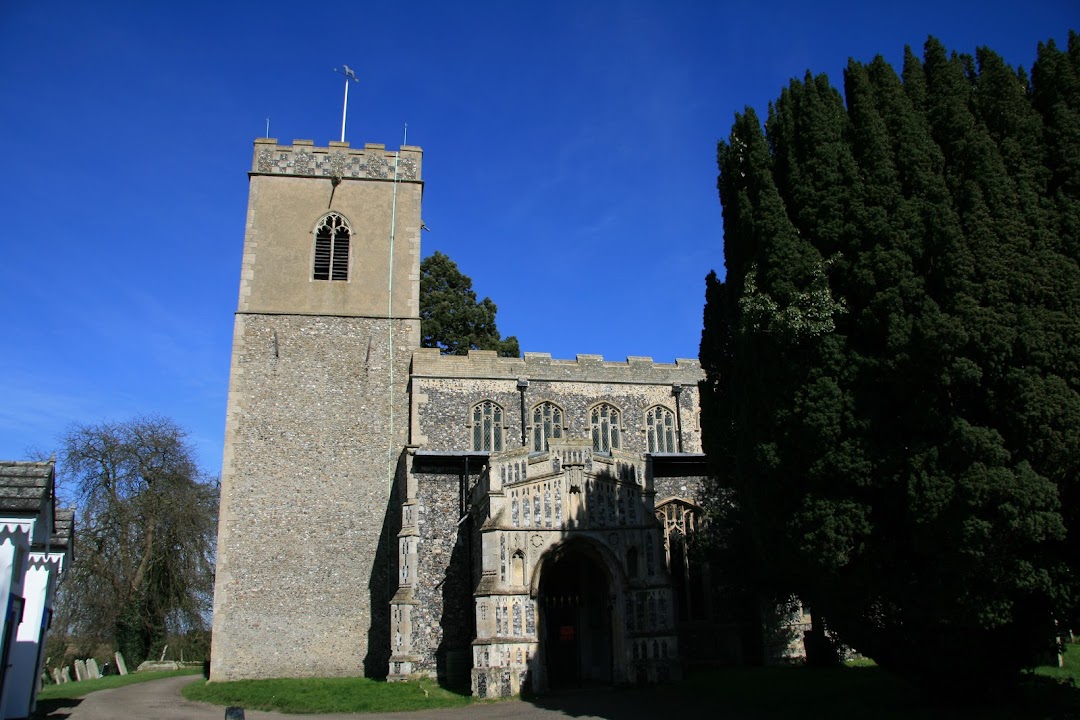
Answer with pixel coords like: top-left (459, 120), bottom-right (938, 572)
top-left (0, 0), bottom-right (1080, 481)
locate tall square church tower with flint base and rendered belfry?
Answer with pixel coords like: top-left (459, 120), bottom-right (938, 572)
top-left (211, 138), bottom-right (423, 680)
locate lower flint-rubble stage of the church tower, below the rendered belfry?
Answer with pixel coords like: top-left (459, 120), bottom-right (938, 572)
top-left (211, 314), bottom-right (418, 681)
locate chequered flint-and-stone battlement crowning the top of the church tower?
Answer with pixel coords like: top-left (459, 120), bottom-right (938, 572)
top-left (252, 137), bottom-right (423, 182)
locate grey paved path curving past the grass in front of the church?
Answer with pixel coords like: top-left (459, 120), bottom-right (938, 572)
top-left (35, 676), bottom-right (738, 720)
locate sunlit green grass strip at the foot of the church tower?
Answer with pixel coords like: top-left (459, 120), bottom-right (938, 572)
top-left (183, 678), bottom-right (473, 712)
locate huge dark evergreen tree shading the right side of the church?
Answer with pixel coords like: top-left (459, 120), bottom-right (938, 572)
top-left (702, 33), bottom-right (1080, 688)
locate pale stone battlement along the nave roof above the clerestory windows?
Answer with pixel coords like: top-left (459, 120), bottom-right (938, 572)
top-left (413, 348), bottom-right (704, 385)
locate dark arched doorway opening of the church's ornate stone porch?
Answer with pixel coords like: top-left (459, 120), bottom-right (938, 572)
top-left (537, 541), bottom-right (613, 690)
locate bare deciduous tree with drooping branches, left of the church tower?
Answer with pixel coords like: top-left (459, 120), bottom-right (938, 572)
top-left (57, 417), bottom-right (218, 662)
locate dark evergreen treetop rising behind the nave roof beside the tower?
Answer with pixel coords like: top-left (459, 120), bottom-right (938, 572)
top-left (420, 250), bottom-right (521, 357)
